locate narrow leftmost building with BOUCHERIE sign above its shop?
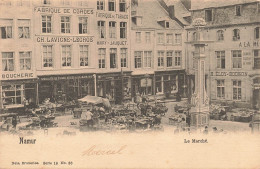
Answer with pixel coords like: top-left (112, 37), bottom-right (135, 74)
top-left (0, 1), bottom-right (37, 109)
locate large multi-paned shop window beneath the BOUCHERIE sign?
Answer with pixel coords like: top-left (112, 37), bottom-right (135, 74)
top-left (2, 84), bottom-right (24, 105)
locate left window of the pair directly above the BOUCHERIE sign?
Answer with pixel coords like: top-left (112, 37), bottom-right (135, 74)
top-left (2, 52), bottom-right (14, 71)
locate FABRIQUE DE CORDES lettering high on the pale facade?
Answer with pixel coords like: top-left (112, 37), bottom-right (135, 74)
top-left (34, 7), bottom-right (94, 15)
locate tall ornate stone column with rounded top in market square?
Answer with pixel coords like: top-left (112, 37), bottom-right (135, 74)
top-left (190, 18), bottom-right (209, 128)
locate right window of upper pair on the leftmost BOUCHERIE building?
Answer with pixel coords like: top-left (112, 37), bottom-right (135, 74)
top-left (18, 19), bottom-right (30, 39)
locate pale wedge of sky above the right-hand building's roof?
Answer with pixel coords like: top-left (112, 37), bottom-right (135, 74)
top-left (191, 0), bottom-right (260, 10)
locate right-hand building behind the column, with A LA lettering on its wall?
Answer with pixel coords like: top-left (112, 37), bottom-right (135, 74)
top-left (186, 1), bottom-right (260, 107)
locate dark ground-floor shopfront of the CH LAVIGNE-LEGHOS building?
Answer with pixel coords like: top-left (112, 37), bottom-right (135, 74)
top-left (39, 74), bottom-right (95, 103)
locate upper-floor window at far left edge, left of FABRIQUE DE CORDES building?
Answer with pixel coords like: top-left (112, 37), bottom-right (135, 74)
top-left (0, 19), bottom-right (13, 39)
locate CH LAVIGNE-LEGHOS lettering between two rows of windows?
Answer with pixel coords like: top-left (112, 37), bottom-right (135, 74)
top-left (36, 36), bottom-right (94, 43)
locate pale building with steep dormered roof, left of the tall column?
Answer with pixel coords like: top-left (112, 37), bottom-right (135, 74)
top-left (131, 0), bottom-right (188, 97)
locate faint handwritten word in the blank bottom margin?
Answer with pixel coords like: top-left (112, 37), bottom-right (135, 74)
top-left (82, 145), bottom-right (127, 156)
